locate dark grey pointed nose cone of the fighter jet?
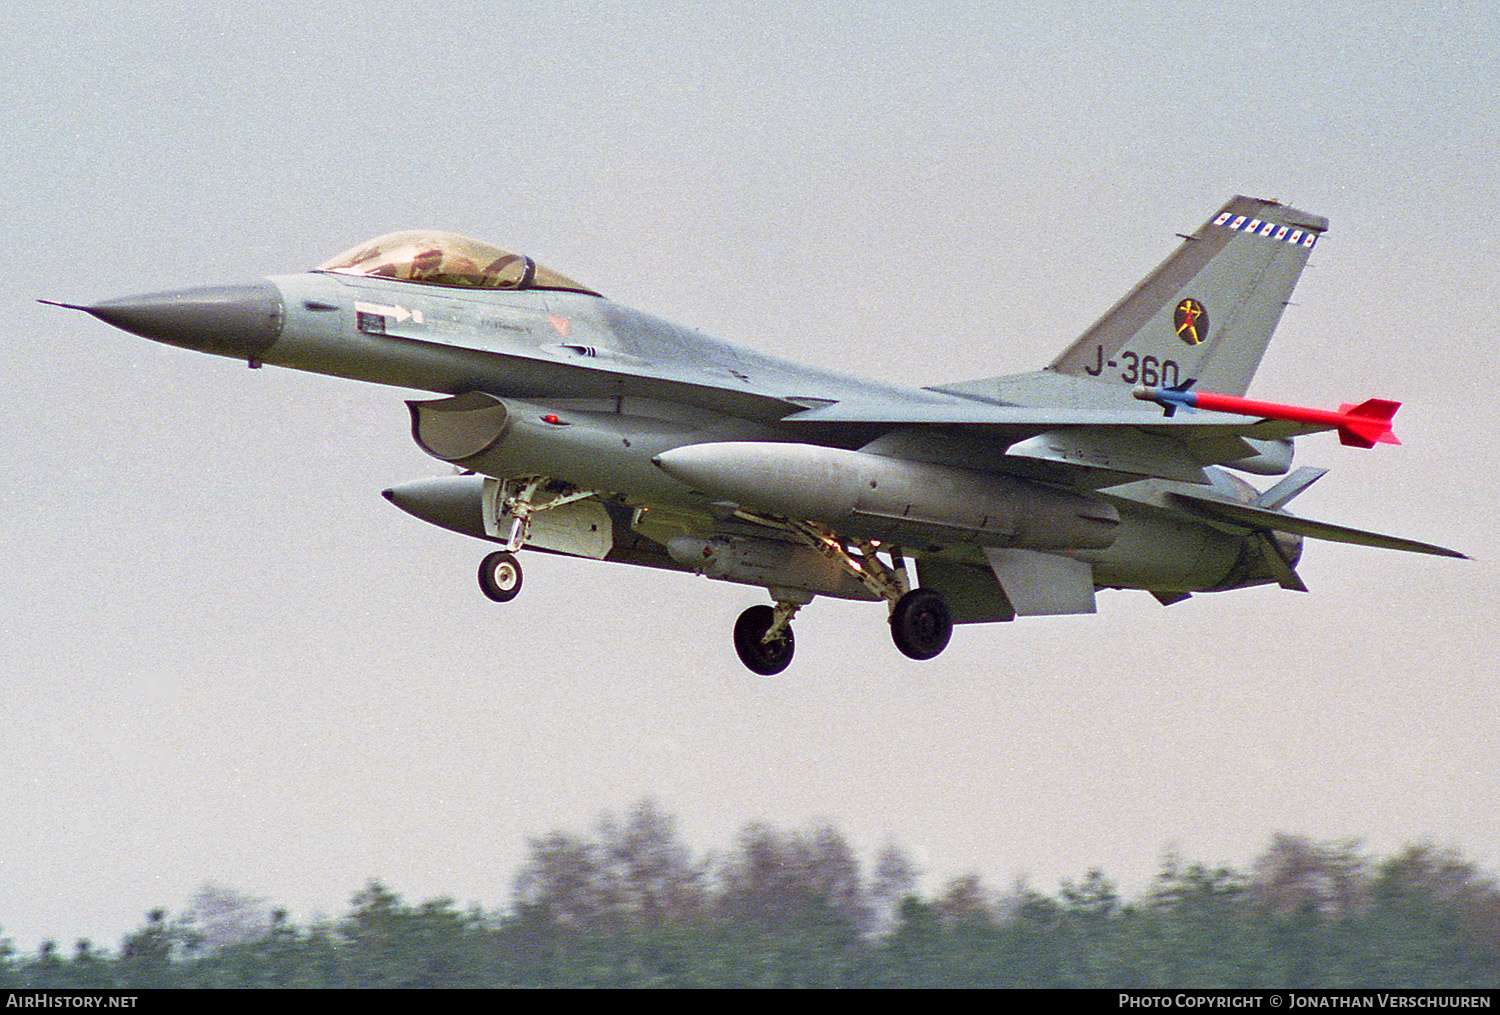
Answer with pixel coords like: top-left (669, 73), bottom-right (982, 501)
top-left (78, 282), bottom-right (282, 361)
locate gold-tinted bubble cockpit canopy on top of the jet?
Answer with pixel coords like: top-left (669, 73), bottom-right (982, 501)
top-left (317, 229), bottom-right (599, 295)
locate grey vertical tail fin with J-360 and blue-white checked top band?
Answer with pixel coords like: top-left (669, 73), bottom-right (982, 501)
top-left (1049, 196), bottom-right (1328, 394)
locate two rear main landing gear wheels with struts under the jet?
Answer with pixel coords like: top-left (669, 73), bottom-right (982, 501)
top-left (723, 519), bottom-right (953, 676)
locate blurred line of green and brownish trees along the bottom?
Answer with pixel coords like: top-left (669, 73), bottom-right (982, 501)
top-left (0, 801), bottom-right (1500, 990)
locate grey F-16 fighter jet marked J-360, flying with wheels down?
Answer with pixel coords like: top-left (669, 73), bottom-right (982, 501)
top-left (46, 196), bottom-right (1463, 675)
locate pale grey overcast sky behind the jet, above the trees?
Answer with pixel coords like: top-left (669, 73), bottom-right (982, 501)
top-left (0, 0), bottom-right (1500, 949)
